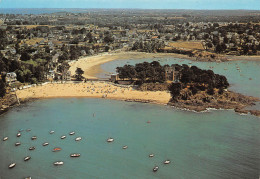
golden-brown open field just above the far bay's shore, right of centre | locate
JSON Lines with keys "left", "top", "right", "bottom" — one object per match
{"left": 168, "top": 41, "right": 204, "bottom": 50}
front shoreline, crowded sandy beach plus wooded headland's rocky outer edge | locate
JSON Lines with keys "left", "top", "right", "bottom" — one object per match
{"left": 13, "top": 81, "right": 260, "bottom": 117}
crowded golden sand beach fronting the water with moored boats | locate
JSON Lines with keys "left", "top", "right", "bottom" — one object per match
{"left": 17, "top": 81, "right": 171, "bottom": 104}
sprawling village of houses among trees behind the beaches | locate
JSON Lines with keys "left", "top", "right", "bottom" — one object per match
{"left": 0, "top": 11, "right": 260, "bottom": 92}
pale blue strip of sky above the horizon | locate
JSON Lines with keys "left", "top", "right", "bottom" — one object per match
{"left": 0, "top": 0, "right": 260, "bottom": 10}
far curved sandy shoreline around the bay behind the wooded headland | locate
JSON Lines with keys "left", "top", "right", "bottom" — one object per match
{"left": 69, "top": 51, "right": 260, "bottom": 79}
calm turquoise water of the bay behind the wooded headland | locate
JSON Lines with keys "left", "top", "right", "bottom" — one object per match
{"left": 98, "top": 58, "right": 260, "bottom": 98}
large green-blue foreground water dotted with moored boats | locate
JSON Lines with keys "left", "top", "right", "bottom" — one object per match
{"left": 0, "top": 98, "right": 260, "bottom": 179}
